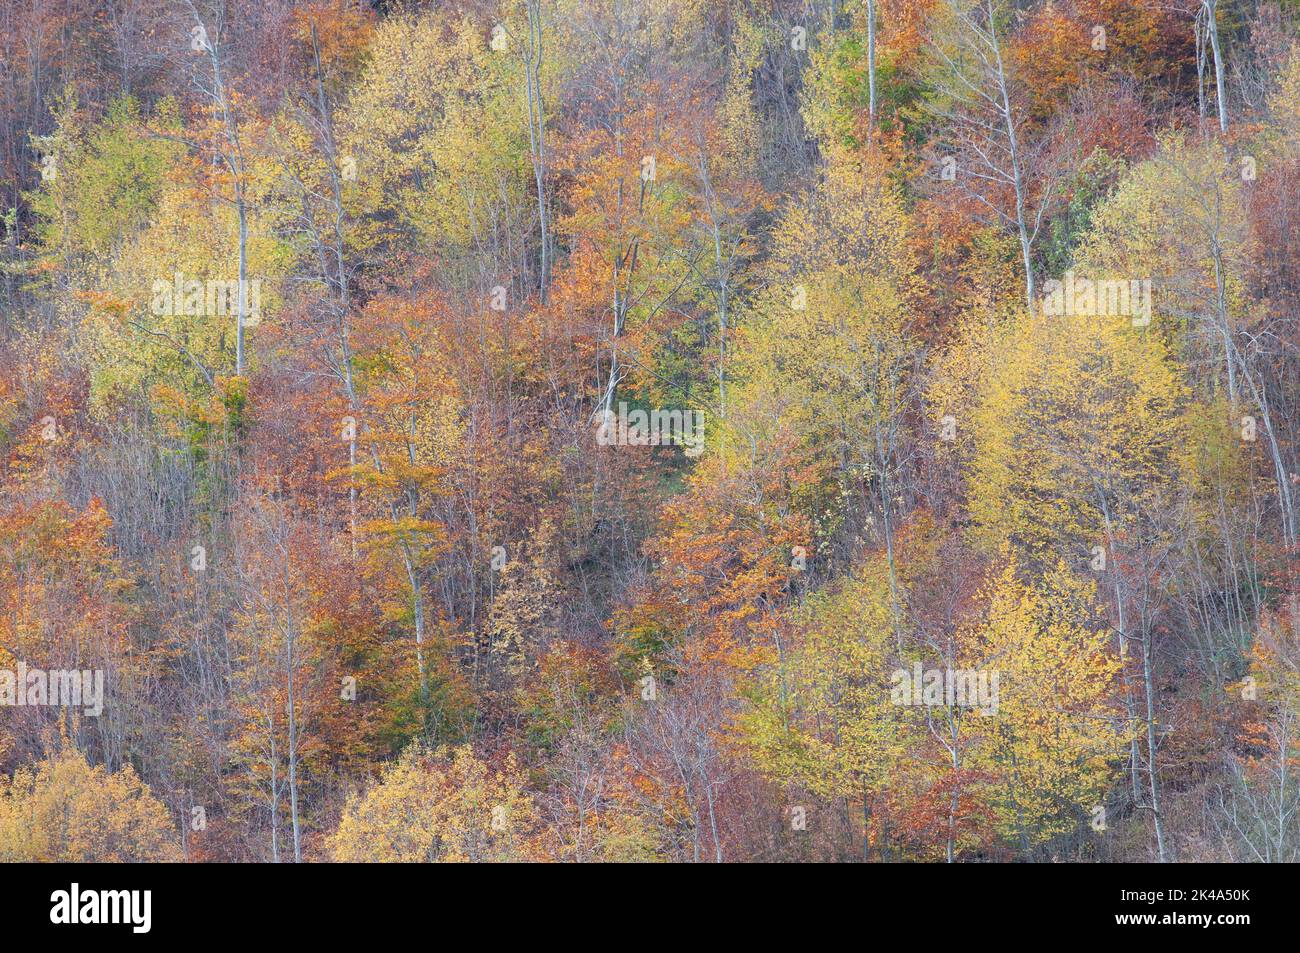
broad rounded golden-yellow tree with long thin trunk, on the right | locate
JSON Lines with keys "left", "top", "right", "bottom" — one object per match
{"left": 932, "top": 301, "right": 1188, "bottom": 853}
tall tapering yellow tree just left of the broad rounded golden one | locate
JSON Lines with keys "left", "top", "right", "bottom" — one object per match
{"left": 736, "top": 148, "right": 919, "bottom": 608}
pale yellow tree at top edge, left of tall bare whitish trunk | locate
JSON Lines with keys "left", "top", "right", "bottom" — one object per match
{"left": 338, "top": 9, "right": 534, "bottom": 294}
